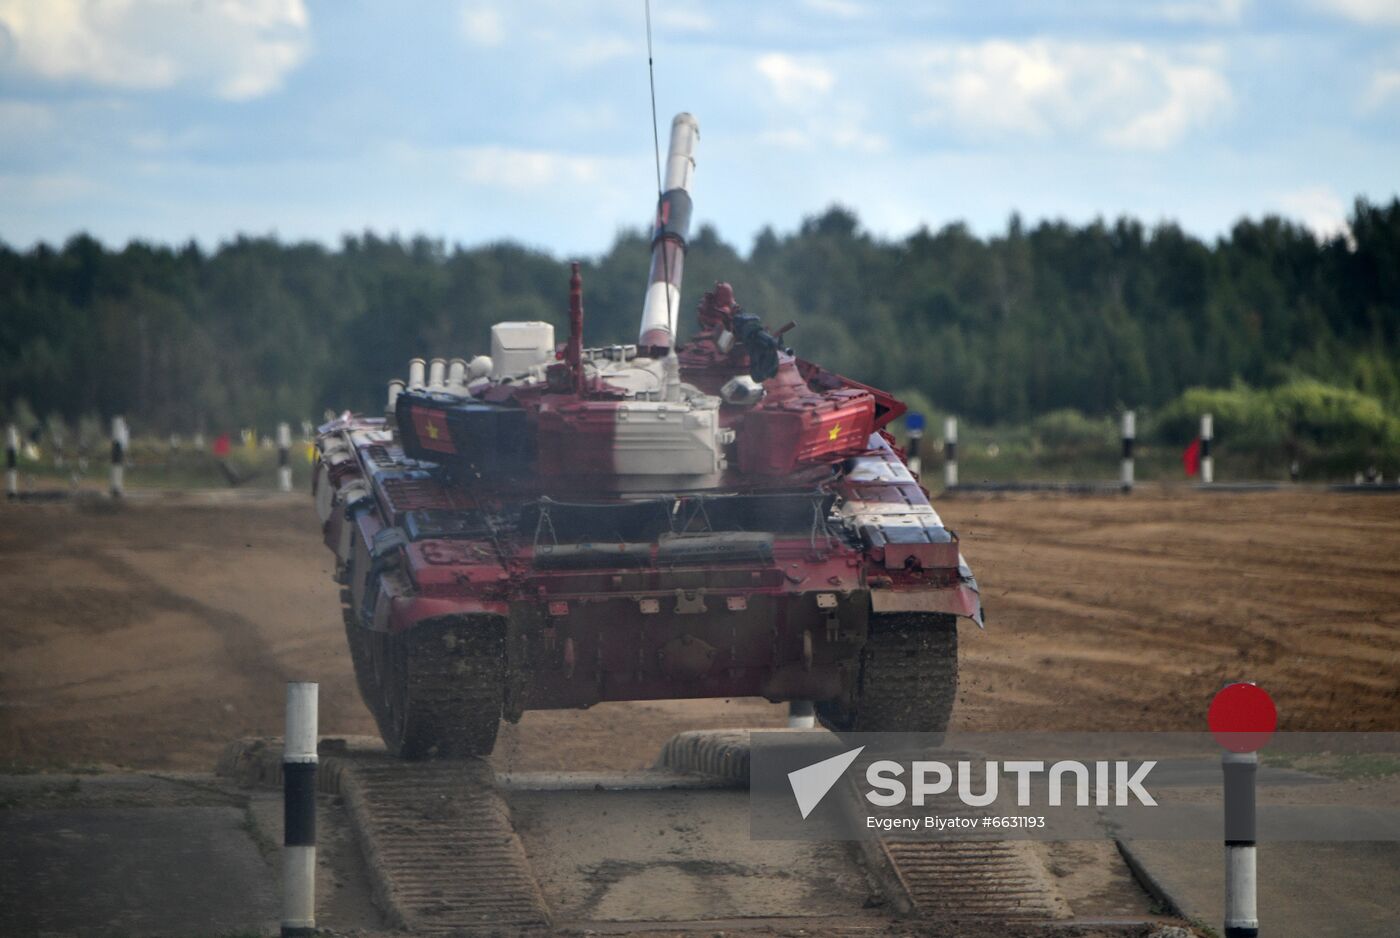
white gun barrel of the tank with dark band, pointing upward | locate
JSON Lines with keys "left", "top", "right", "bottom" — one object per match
{"left": 637, "top": 112, "right": 700, "bottom": 356}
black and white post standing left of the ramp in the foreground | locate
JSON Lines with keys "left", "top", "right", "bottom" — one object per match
{"left": 281, "top": 680, "right": 319, "bottom": 938}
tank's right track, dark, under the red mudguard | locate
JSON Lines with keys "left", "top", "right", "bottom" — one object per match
{"left": 816, "top": 612, "right": 958, "bottom": 732}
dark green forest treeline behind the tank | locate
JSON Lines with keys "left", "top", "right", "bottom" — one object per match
{"left": 0, "top": 200, "right": 1400, "bottom": 445}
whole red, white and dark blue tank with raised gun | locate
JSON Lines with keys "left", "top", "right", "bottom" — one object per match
{"left": 314, "top": 113, "right": 981, "bottom": 759}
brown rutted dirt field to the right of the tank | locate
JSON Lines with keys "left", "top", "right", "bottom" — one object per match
{"left": 939, "top": 491, "right": 1400, "bottom": 729}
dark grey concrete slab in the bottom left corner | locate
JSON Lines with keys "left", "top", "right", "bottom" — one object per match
{"left": 0, "top": 806, "right": 279, "bottom": 938}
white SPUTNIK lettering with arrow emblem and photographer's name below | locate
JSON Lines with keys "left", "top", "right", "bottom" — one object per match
{"left": 788, "top": 746, "right": 1156, "bottom": 829}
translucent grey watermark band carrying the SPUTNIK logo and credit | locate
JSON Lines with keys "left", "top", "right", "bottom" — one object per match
{"left": 749, "top": 731, "right": 1400, "bottom": 841}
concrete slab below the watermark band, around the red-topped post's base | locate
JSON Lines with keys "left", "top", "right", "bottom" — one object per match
{"left": 1126, "top": 840, "right": 1400, "bottom": 938}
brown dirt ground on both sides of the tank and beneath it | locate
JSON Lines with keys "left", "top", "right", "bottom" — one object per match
{"left": 0, "top": 491, "right": 1400, "bottom": 770}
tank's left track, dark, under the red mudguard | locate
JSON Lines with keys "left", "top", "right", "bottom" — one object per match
{"left": 344, "top": 603, "right": 505, "bottom": 760}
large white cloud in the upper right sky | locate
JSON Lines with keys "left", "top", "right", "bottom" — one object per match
{"left": 920, "top": 39, "right": 1231, "bottom": 150}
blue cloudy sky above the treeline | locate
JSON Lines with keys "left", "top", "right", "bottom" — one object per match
{"left": 0, "top": 0, "right": 1400, "bottom": 256}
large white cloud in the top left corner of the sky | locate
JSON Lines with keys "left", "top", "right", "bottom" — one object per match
{"left": 0, "top": 0, "right": 309, "bottom": 101}
